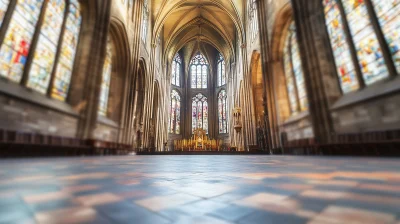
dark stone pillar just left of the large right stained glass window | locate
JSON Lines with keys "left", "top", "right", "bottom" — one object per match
{"left": 292, "top": 0, "right": 334, "bottom": 143}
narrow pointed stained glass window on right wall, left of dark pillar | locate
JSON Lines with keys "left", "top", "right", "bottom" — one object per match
{"left": 283, "top": 22, "right": 308, "bottom": 113}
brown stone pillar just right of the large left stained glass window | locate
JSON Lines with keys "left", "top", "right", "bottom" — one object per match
{"left": 75, "top": 0, "right": 111, "bottom": 139}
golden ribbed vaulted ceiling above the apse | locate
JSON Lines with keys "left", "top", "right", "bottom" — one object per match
{"left": 152, "top": 0, "right": 244, "bottom": 63}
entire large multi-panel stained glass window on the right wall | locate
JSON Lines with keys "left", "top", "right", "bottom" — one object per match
{"left": 323, "top": 0, "right": 400, "bottom": 93}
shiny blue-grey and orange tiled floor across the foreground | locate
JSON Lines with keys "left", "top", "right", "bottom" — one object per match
{"left": 0, "top": 156, "right": 400, "bottom": 224}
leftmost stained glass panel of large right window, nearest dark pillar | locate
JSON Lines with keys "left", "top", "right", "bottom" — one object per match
{"left": 324, "top": 0, "right": 359, "bottom": 93}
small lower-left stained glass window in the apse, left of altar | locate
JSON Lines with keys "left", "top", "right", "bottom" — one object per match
{"left": 169, "top": 90, "right": 181, "bottom": 134}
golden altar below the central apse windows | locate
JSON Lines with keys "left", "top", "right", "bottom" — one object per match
{"left": 174, "top": 128, "right": 222, "bottom": 151}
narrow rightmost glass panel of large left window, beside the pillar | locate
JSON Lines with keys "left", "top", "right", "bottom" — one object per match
{"left": 51, "top": 0, "right": 82, "bottom": 101}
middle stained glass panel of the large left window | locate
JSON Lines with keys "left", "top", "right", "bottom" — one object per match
{"left": 27, "top": 0, "right": 65, "bottom": 94}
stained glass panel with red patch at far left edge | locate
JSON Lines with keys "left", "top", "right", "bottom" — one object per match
{"left": 0, "top": 0, "right": 44, "bottom": 82}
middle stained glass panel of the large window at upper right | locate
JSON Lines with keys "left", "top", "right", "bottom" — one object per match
{"left": 343, "top": 0, "right": 389, "bottom": 85}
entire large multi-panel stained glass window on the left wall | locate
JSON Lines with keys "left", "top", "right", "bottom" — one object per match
{"left": 0, "top": 0, "right": 81, "bottom": 100}
